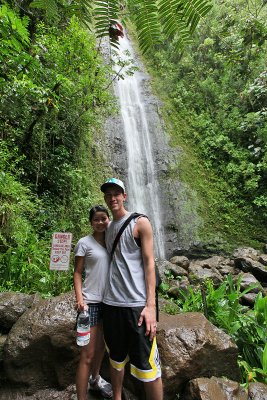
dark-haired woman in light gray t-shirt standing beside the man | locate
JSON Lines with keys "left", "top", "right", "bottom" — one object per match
{"left": 73, "top": 205, "right": 113, "bottom": 400}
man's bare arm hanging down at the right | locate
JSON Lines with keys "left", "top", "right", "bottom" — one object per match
{"left": 136, "top": 217, "right": 157, "bottom": 340}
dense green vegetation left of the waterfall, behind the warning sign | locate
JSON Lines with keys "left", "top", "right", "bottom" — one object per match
{"left": 0, "top": 5, "right": 113, "bottom": 296}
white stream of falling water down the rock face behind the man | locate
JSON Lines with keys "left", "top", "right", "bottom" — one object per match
{"left": 112, "top": 35, "right": 165, "bottom": 258}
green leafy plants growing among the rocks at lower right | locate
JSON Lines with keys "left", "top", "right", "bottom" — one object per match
{"left": 161, "top": 275, "right": 267, "bottom": 384}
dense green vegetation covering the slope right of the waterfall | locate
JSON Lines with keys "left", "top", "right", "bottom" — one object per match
{"left": 143, "top": 0, "right": 267, "bottom": 248}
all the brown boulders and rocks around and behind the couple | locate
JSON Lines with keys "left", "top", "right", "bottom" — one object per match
{"left": 0, "top": 248, "right": 267, "bottom": 400}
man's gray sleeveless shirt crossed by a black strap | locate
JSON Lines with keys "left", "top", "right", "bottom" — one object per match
{"left": 103, "top": 214, "right": 149, "bottom": 307}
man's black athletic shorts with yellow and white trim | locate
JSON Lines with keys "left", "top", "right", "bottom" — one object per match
{"left": 103, "top": 304, "right": 161, "bottom": 382}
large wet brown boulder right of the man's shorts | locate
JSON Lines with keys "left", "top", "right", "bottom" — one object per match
{"left": 157, "top": 313, "right": 240, "bottom": 400}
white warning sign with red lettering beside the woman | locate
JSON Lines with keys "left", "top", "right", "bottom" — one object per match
{"left": 50, "top": 232, "right": 72, "bottom": 271}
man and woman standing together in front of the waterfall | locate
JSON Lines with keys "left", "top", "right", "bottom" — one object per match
{"left": 74, "top": 178, "right": 163, "bottom": 400}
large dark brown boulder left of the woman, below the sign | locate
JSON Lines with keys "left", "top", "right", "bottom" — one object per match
{"left": 3, "top": 292, "right": 79, "bottom": 392}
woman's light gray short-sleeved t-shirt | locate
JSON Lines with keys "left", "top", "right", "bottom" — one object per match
{"left": 74, "top": 235, "right": 110, "bottom": 303}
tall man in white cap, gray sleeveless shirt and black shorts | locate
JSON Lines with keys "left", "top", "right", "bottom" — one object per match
{"left": 101, "top": 178, "right": 163, "bottom": 400}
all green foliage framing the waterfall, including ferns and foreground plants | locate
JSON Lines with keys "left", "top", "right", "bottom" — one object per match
{"left": 0, "top": 0, "right": 267, "bottom": 390}
